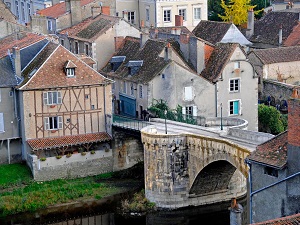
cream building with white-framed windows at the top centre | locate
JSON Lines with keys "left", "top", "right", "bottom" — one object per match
{"left": 116, "top": 0, "right": 207, "bottom": 30}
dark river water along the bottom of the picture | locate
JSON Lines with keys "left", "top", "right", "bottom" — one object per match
{"left": 0, "top": 199, "right": 247, "bottom": 225}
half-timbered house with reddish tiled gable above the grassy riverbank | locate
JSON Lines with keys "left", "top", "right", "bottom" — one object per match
{"left": 18, "top": 42, "right": 113, "bottom": 180}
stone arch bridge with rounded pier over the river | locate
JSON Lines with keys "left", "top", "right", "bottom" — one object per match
{"left": 141, "top": 126, "right": 250, "bottom": 208}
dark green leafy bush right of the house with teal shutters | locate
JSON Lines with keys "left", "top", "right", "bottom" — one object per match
{"left": 258, "top": 104, "right": 287, "bottom": 135}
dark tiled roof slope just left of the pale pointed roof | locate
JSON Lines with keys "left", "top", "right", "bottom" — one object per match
{"left": 192, "top": 20, "right": 232, "bottom": 45}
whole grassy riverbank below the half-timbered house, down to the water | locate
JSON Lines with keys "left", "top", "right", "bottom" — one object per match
{"left": 0, "top": 164, "right": 143, "bottom": 224}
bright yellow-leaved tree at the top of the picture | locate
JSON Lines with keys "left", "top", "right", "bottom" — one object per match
{"left": 219, "top": 0, "right": 261, "bottom": 26}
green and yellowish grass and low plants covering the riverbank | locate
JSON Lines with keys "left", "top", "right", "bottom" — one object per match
{"left": 0, "top": 164, "right": 143, "bottom": 217}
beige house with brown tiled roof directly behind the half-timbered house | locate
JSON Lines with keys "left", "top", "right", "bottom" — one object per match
{"left": 57, "top": 14, "right": 141, "bottom": 70}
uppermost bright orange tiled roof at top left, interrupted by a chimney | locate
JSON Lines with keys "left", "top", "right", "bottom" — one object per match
{"left": 37, "top": 0, "right": 94, "bottom": 18}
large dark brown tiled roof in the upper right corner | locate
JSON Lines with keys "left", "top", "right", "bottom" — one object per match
{"left": 250, "top": 11, "right": 299, "bottom": 46}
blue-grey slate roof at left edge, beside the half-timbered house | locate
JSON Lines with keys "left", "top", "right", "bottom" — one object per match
{"left": 0, "top": 56, "right": 17, "bottom": 87}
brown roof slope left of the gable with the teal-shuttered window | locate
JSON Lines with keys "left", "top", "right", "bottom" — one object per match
{"left": 200, "top": 43, "right": 239, "bottom": 82}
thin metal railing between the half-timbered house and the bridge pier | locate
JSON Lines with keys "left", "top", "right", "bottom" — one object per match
{"left": 113, "top": 114, "right": 151, "bottom": 130}
